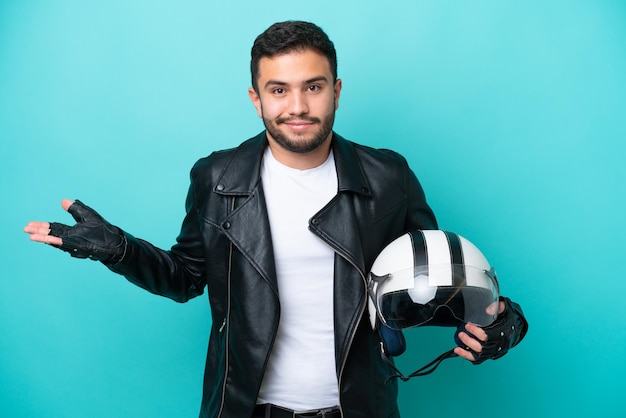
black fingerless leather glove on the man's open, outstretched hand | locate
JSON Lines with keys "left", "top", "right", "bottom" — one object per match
{"left": 50, "top": 200, "right": 126, "bottom": 264}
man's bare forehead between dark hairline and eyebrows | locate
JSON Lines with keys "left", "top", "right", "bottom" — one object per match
{"left": 258, "top": 49, "right": 332, "bottom": 85}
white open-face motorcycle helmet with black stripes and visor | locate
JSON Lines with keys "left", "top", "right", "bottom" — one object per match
{"left": 368, "top": 230, "right": 499, "bottom": 330}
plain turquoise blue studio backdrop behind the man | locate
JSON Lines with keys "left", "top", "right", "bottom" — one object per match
{"left": 0, "top": 0, "right": 626, "bottom": 417}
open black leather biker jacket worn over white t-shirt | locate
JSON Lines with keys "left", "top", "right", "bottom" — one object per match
{"left": 110, "top": 132, "right": 437, "bottom": 418}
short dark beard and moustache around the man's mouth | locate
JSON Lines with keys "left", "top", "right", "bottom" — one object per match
{"left": 263, "top": 110, "right": 335, "bottom": 154}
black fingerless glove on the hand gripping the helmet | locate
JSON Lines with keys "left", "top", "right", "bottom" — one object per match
{"left": 469, "top": 296, "right": 528, "bottom": 364}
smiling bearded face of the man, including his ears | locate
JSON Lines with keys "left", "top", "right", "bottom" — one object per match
{"left": 248, "top": 50, "right": 341, "bottom": 154}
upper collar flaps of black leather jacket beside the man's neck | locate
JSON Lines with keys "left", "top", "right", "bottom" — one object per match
{"left": 215, "top": 131, "right": 370, "bottom": 196}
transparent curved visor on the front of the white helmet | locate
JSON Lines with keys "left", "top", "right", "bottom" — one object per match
{"left": 370, "top": 265, "right": 499, "bottom": 330}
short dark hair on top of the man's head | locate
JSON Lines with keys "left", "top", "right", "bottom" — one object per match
{"left": 250, "top": 20, "right": 337, "bottom": 91}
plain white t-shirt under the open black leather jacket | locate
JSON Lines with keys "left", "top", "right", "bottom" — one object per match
{"left": 257, "top": 147, "right": 339, "bottom": 411}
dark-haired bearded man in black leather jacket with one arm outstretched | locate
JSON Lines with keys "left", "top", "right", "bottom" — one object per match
{"left": 25, "top": 22, "right": 524, "bottom": 418}
